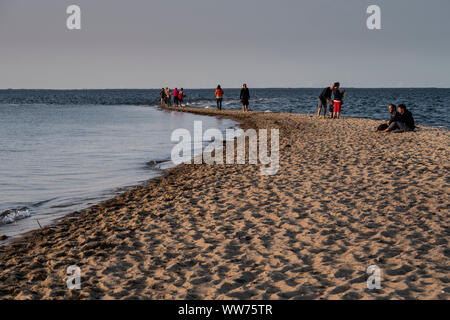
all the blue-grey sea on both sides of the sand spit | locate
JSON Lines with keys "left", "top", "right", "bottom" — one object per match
{"left": 0, "top": 88, "right": 450, "bottom": 241}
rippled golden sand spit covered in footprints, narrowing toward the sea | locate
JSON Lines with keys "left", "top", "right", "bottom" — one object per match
{"left": 0, "top": 108, "right": 450, "bottom": 299}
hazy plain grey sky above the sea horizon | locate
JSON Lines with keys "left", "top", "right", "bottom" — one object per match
{"left": 0, "top": 0, "right": 450, "bottom": 89}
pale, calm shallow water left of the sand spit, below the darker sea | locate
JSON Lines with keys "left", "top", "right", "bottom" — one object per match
{"left": 0, "top": 99, "right": 235, "bottom": 236}
